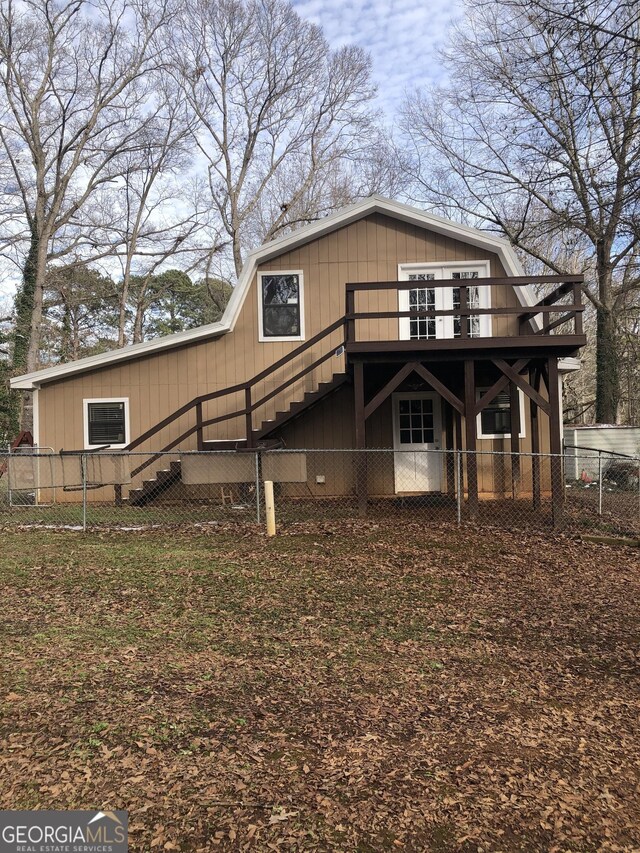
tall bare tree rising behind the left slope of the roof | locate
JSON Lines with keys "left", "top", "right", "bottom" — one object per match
{"left": 172, "top": 0, "right": 374, "bottom": 273}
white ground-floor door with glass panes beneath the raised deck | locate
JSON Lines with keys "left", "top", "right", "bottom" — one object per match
{"left": 393, "top": 391, "right": 442, "bottom": 493}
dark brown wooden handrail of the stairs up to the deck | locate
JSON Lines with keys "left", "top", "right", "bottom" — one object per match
{"left": 124, "top": 317, "right": 346, "bottom": 475}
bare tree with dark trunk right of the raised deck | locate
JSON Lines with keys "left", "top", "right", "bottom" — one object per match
{"left": 403, "top": 0, "right": 640, "bottom": 422}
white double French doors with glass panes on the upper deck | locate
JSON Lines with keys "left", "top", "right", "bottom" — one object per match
{"left": 398, "top": 261, "right": 491, "bottom": 340}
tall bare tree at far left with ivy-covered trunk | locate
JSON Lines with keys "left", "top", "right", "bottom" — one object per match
{"left": 0, "top": 0, "right": 169, "bottom": 425}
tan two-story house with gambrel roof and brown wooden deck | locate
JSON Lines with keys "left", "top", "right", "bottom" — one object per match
{"left": 11, "top": 196, "right": 585, "bottom": 503}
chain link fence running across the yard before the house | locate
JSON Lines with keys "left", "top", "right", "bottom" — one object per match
{"left": 0, "top": 447, "right": 640, "bottom": 537}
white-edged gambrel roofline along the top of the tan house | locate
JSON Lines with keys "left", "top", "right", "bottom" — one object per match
{"left": 11, "top": 195, "right": 536, "bottom": 390}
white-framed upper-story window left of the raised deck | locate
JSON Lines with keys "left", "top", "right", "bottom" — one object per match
{"left": 258, "top": 270, "right": 304, "bottom": 341}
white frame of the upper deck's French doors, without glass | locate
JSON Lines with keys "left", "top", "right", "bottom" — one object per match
{"left": 398, "top": 259, "right": 492, "bottom": 341}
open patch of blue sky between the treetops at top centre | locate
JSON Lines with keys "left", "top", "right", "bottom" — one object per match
{"left": 293, "top": 0, "right": 459, "bottom": 114}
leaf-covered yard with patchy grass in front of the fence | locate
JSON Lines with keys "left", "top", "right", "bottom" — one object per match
{"left": 0, "top": 523, "right": 640, "bottom": 853}
